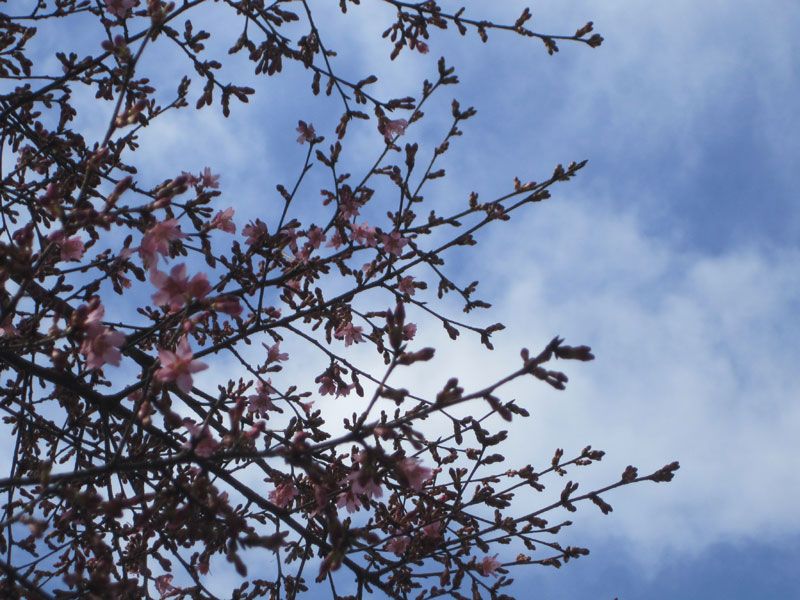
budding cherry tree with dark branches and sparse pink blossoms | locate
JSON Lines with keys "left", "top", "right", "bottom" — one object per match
{"left": 0, "top": 0, "right": 678, "bottom": 598}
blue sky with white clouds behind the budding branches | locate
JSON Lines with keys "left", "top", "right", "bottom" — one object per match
{"left": 7, "top": 0, "right": 800, "bottom": 600}
